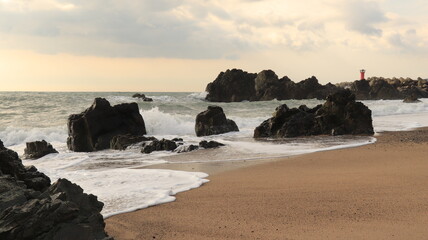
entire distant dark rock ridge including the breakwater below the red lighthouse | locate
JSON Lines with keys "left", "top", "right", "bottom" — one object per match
{"left": 206, "top": 69, "right": 428, "bottom": 102}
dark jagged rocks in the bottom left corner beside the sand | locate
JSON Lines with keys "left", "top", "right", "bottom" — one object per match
{"left": 0, "top": 141, "right": 112, "bottom": 240}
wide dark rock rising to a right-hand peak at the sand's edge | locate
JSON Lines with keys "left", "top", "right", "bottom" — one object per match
{"left": 254, "top": 90, "right": 373, "bottom": 138}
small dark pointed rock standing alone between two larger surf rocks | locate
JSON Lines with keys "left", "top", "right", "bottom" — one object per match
{"left": 195, "top": 106, "right": 239, "bottom": 137}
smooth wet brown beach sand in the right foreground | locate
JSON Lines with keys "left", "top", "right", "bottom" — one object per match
{"left": 106, "top": 128, "right": 428, "bottom": 240}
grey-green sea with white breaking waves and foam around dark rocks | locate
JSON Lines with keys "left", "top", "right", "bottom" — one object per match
{"left": 0, "top": 92, "right": 428, "bottom": 218}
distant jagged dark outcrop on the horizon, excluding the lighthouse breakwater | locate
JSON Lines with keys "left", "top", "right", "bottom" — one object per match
{"left": 206, "top": 69, "right": 340, "bottom": 102}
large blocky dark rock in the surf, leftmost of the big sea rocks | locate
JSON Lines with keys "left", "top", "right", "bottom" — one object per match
{"left": 67, "top": 98, "right": 146, "bottom": 152}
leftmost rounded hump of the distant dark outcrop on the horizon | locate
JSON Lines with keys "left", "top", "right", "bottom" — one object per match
{"left": 206, "top": 69, "right": 256, "bottom": 102}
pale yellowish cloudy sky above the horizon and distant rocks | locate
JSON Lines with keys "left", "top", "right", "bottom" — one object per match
{"left": 0, "top": 0, "right": 428, "bottom": 92}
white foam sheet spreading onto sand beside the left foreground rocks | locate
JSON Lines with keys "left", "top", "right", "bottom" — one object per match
{"left": 24, "top": 156, "right": 208, "bottom": 218}
